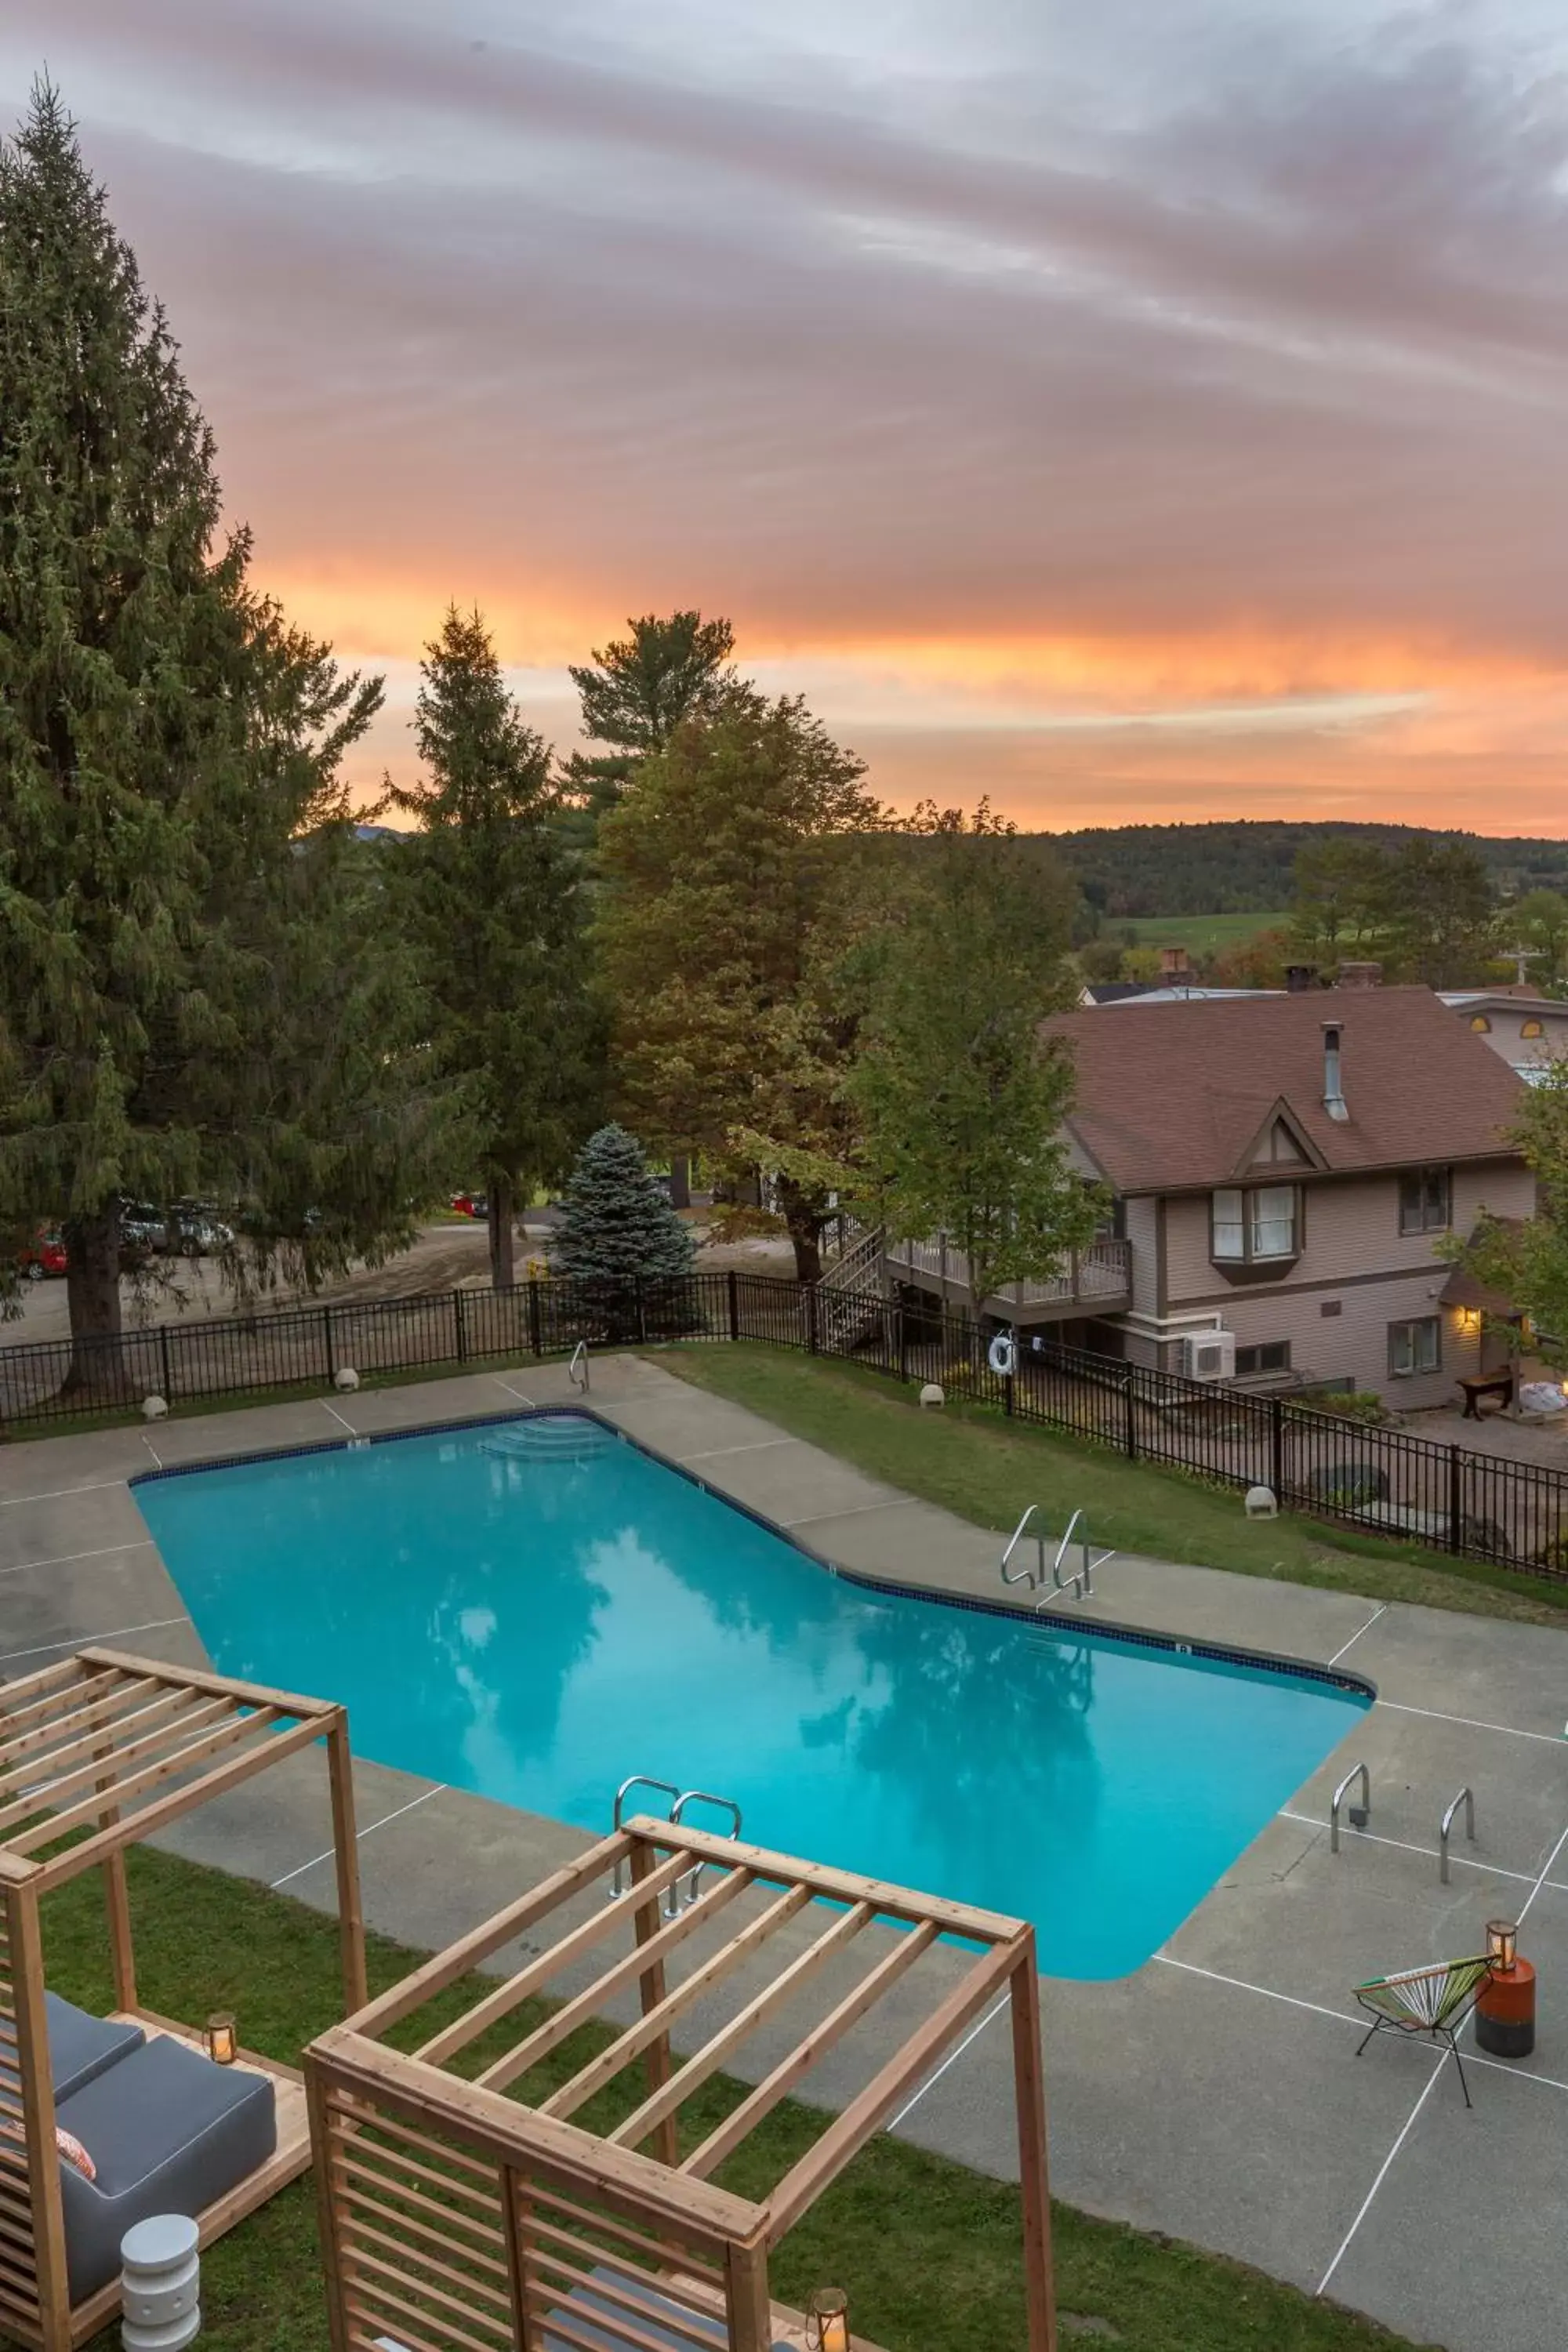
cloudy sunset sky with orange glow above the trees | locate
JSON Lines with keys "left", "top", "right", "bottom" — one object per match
{"left": 0, "top": 0, "right": 1568, "bottom": 833}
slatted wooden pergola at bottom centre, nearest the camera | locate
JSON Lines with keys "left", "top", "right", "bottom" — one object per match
{"left": 306, "top": 1818, "right": 1055, "bottom": 2352}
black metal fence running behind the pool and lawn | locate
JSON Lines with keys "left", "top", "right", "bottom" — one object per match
{"left": 0, "top": 1272, "right": 1568, "bottom": 1581}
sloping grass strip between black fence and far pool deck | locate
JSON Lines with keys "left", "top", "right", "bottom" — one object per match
{"left": 649, "top": 1343, "right": 1568, "bottom": 1625}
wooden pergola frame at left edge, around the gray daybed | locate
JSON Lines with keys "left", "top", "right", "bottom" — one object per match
{"left": 0, "top": 1649, "right": 367, "bottom": 2352}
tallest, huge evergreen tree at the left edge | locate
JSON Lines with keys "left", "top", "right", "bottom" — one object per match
{"left": 0, "top": 82, "right": 440, "bottom": 1381}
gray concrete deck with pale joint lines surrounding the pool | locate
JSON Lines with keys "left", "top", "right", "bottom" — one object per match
{"left": 0, "top": 1357, "right": 1568, "bottom": 2352}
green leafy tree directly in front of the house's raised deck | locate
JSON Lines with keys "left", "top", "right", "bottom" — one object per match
{"left": 848, "top": 804, "right": 1109, "bottom": 1305}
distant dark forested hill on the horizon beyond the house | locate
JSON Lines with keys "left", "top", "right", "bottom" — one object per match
{"left": 1051, "top": 821, "right": 1568, "bottom": 915}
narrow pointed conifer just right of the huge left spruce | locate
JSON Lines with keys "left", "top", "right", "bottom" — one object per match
{"left": 393, "top": 604, "right": 600, "bottom": 1287}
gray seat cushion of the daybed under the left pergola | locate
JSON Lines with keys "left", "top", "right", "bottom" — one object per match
{"left": 56, "top": 2034, "right": 278, "bottom": 2303}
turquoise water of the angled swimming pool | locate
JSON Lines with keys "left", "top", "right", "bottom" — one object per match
{"left": 136, "top": 1418, "right": 1366, "bottom": 1978}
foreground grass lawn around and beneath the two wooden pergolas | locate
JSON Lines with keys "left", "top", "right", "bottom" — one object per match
{"left": 45, "top": 1846, "right": 1429, "bottom": 2352}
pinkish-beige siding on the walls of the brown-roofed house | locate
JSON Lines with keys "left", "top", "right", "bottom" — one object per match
{"left": 1147, "top": 1162, "right": 1533, "bottom": 1409}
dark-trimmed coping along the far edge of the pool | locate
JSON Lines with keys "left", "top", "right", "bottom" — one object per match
{"left": 127, "top": 1404, "right": 1377, "bottom": 1705}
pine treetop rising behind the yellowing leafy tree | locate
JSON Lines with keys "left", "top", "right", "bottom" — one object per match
{"left": 567, "top": 612, "right": 736, "bottom": 826}
